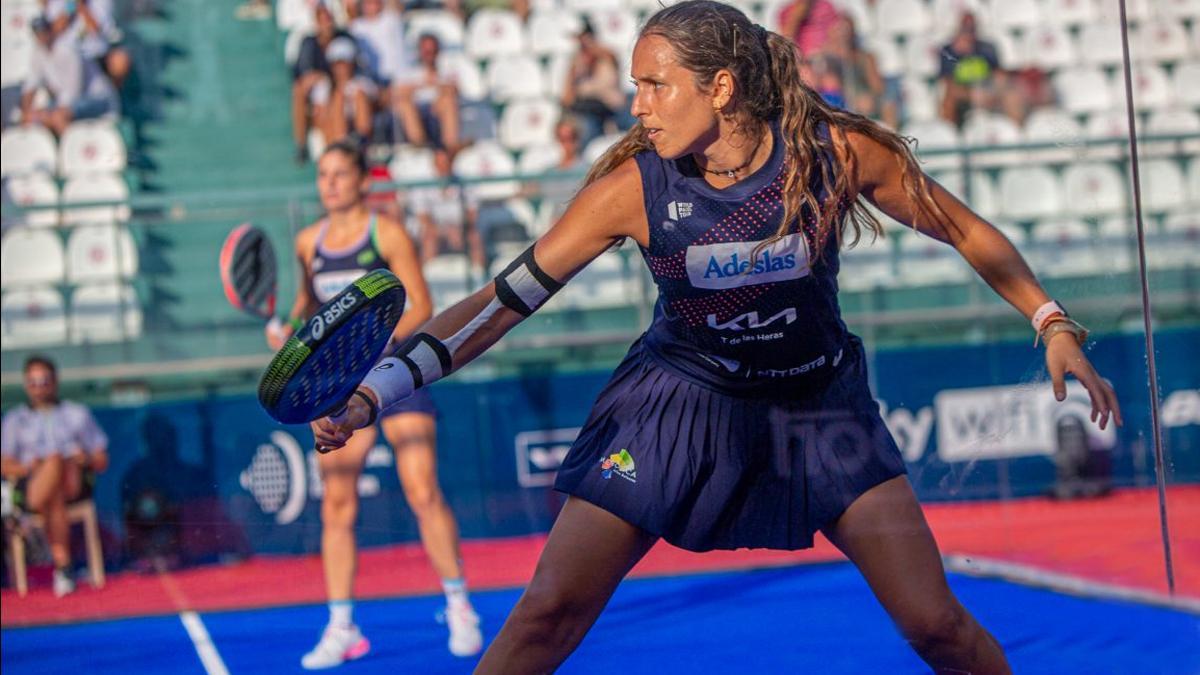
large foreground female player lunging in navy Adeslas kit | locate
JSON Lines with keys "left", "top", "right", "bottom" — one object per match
{"left": 314, "top": 0, "right": 1121, "bottom": 674}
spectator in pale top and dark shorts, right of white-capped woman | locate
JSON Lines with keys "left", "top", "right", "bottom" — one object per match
{"left": 392, "top": 34, "right": 462, "bottom": 153}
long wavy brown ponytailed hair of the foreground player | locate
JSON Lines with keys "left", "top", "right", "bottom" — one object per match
{"left": 583, "top": 0, "right": 946, "bottom": 256}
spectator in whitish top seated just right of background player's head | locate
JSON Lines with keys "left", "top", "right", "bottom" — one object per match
{"left": 408, "top": 149, "right": 487, "bottom": 269}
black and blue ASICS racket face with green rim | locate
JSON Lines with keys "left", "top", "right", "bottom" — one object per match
{"left": 258, "top": 270, "right": 404, "bottom": 424}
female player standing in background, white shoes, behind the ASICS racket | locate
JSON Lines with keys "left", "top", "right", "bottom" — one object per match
{"left": 266, "top": 143, "right": 482, "bottom": 668}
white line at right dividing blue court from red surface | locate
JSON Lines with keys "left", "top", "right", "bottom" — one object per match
{"left": 944, "top": 555, "right": 1200, "bottom": 614}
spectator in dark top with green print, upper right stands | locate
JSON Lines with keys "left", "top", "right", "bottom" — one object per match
{"left": 938, "top": 12, "right": 1026, "bottom": 125}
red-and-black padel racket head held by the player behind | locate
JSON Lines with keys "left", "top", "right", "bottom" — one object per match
{"left": 221, "top": 222, "right": 276, "bottom": 318}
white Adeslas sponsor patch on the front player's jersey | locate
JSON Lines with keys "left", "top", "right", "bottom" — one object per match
{"left": 688, "top": 234, "right": 810, "bottom": 288}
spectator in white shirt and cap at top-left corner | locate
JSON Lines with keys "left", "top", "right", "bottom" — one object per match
{"left": 20, "top": 0, "right": 120, "bottom": 135}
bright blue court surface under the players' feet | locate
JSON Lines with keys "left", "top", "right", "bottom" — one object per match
{"left": 2, "top": 565, "right": 1200, "bottom": 675}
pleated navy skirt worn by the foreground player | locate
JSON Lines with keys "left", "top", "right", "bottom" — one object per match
{"left": 554, "top": 339, "right": 905, "bottom": 551}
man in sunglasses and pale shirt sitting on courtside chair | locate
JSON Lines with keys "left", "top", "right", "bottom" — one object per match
{"left": 0, "top": 357, "right": 108, "bottom": 597}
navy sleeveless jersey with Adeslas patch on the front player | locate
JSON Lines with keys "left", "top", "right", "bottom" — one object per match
{"left": 635, "top": 124, "right": 848, "bottom": 395}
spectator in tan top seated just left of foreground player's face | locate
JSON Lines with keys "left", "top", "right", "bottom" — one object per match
{"left": 562, "top": 19, "right": 631, "bottom": 145}
